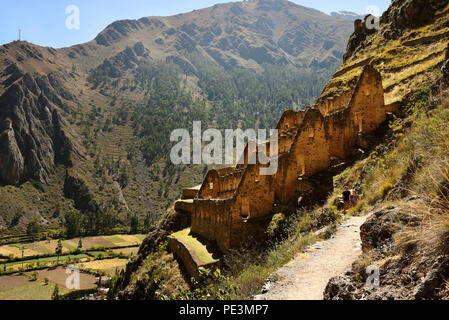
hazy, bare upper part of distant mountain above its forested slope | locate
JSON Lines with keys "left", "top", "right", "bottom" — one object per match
{"left": 89, "top": 0, "right": 353, "bottom": 69}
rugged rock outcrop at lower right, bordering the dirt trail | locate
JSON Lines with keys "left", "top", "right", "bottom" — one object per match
{"left": 324, "top": 205, "right": 449, "bottom": 300}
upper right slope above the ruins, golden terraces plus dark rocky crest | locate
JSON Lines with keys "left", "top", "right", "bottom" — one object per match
{"left": 320, "top": 1, "right": 449, "bottom": 104}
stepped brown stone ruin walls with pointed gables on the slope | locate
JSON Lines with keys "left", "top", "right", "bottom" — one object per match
{"left": 178, "top": 65, "right": 389, "bottom": 252}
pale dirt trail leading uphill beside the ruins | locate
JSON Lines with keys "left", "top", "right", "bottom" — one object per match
{"left": 255, "top": 216, "right": 367, "bottom": 300}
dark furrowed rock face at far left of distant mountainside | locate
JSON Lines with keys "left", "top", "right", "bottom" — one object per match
{"left": 0, "top": 65, "right": 81, "bottom": 185}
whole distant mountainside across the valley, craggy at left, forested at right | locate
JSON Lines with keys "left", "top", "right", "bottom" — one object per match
{"left": 0, "top": 0, "right": 352, "bottom": 237}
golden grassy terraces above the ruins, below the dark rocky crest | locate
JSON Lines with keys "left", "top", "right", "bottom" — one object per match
{"left": 319, "top": 13, "right": 449, "bottom": 104}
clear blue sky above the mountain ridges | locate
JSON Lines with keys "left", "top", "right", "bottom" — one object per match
{"left": 0, "top": 0, "right": 391, "bottom": 48}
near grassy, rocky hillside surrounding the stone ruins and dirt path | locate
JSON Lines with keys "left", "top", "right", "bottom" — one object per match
{"left": 114, "top": 0, "right": 449, "bottom": 299}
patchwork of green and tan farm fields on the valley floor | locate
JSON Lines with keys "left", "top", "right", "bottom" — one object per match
{"left": 0, "top": 234, "right": 145, "bottom": 300}
